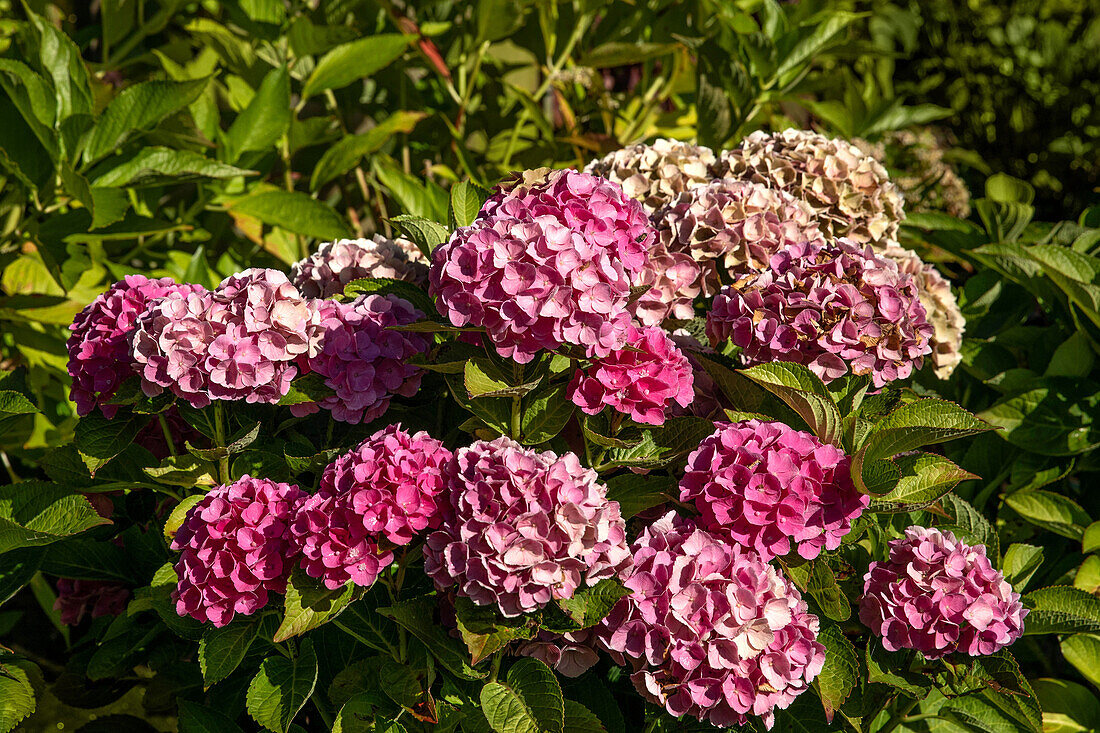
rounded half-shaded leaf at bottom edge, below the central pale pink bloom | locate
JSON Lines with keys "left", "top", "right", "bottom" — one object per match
{"left": 481, "top": 657, "right": 565, "bottom": 733}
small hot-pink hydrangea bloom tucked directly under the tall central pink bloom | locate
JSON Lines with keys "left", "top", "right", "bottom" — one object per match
{"left": 569, "top": 326, "right": 695, "bottom": 425}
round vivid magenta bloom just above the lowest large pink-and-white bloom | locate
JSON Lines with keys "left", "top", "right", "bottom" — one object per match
{"left": 680, "top": 420, "right": 870, "bottom": 560}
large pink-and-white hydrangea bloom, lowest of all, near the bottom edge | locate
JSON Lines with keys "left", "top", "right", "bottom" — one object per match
{"left": 597, "top": 512, "right": 825, "bottom": 727}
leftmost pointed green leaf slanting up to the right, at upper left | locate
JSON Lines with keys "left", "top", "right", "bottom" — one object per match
{"left": 84, "top": 77, "right": 209, "bottom": 164}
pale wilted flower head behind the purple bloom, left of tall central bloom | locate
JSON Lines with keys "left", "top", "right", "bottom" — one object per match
{"left": 290, "top": 234, "right": 428, "bottom": 298}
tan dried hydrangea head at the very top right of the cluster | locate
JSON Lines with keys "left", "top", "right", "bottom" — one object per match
{"left": 718, "top": 130, "right": 905, "bottom": 244}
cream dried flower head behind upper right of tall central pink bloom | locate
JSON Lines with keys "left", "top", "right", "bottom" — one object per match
{"left": 584, "top": 138, "right": 718, "bottom": 214}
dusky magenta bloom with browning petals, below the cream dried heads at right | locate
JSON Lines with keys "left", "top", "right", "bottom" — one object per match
{"left": 706, "top": 240, "right": 934, "bottom": 387}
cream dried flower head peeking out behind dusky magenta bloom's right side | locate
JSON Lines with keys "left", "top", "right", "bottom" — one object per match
{"left": 881, "top": 240, "right": 966, "bottom": 380}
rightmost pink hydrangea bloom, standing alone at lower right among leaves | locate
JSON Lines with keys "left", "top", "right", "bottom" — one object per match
{"left": 859, "top": 527, "right": 1027, "bottom": 659}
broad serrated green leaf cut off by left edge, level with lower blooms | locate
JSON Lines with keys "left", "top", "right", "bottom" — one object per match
{"left": 0, "top": 481, "right": 110, "bottom": 553}
